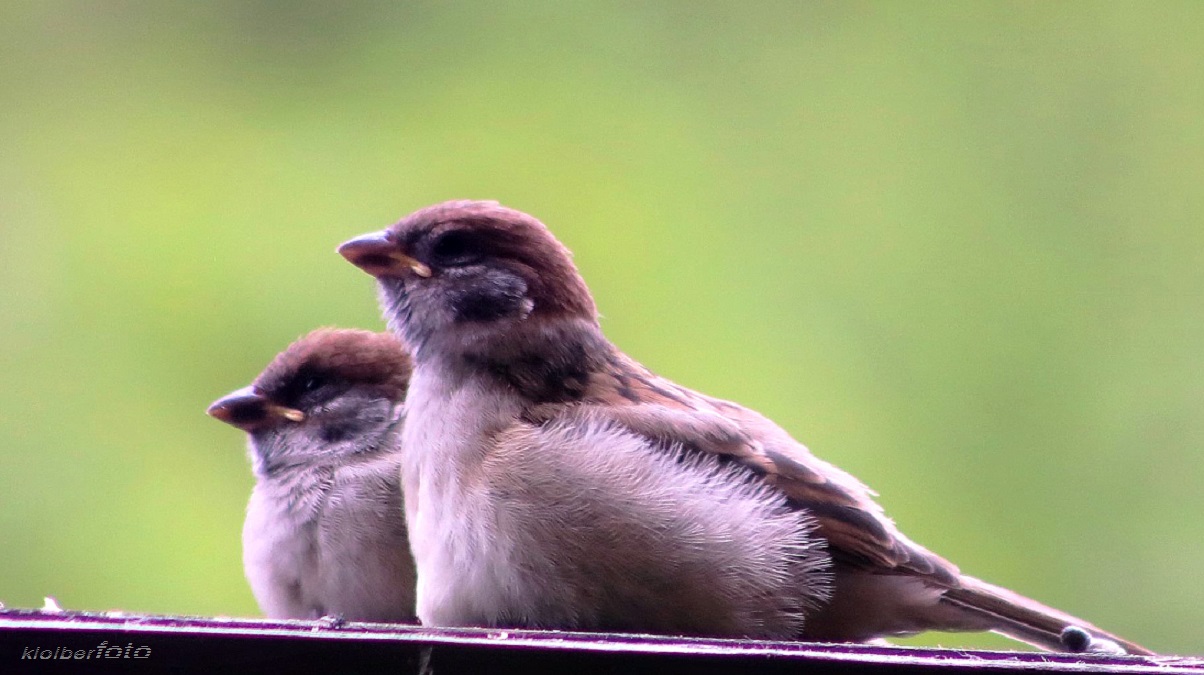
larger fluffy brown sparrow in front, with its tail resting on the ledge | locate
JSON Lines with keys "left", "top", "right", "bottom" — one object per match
{"left": 338, "top": 201, "right": 1150, "bottom": 653}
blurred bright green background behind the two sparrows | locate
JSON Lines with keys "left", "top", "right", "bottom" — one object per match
{"left": 0, "top": 1, "right": 1204, "bottom": 653}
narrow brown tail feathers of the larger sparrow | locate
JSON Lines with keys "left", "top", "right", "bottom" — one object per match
{"left": 942, "top": 576, "right": 1153, "bottom": 655}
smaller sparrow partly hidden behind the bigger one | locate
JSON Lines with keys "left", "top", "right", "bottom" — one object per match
{"left": 208, "top": 328, "right": 415, "bottom": 622}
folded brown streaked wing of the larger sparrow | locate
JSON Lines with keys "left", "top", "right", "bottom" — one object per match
{"left": 530, "top": 353, "right": 958, "bottom": 587}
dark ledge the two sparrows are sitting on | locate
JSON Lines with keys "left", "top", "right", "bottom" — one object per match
{"left": 0, "top": 609, "right": 1204, "bottom": 675}
